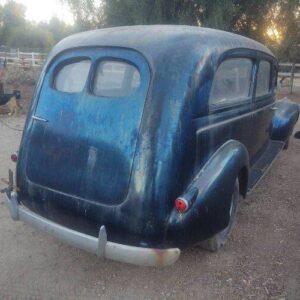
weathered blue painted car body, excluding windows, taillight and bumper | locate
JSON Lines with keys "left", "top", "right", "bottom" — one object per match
{"left": 17, "top": 26, "right": 300, "bottom": 248}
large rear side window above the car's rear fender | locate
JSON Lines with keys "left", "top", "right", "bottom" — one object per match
{"left": 209, "top": 58, "right": 253, "bottom": 109}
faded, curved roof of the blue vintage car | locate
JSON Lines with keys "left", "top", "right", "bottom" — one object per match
{"left": 49, "top": 25, "right": 274, "bottom": 61}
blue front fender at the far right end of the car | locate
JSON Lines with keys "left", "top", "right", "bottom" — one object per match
{"left": 271, "top": 101, "right": 299, "bottom": 142}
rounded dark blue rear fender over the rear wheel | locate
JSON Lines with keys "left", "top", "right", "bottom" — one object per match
{"left": 167, "top": 140, "right": 249, "bottom": 247}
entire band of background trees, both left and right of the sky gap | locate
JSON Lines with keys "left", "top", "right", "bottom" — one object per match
{"left": 0, "top": 0, "right": 300, "bottom": 61}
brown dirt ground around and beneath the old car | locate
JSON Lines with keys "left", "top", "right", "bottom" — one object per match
{"left": 0, "top": 88, "right": 300, "bottom": 300}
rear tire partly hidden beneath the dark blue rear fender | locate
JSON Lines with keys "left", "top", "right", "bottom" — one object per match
{"left": 199, "top": 179, "right": 240, "bottom": 252}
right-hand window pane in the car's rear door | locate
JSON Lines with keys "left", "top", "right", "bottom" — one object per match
{"left": 93, "top": 60, "right": 141, "bottom": 97}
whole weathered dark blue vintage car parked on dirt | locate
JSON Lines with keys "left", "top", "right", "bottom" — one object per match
{"left": 3, "top": 26, "right": 299, "bottom": 266}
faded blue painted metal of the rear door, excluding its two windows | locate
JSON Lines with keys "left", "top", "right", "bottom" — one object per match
{"left": 26, "top": 49, "right": 150, "bottom": 205}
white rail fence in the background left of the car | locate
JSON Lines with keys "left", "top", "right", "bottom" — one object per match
{"left": 0, "top": 51, "right": 47, "bottom": 68}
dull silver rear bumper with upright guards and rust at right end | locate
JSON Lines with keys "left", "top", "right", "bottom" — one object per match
{"left": 5, "top": 193, "right": 180, "bottom": 266}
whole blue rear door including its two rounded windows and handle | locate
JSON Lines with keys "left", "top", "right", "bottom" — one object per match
{"left": 24, "top": 49, "right": 150, "bottom": 205}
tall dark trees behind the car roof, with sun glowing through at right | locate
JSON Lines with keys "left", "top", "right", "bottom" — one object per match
{"left": 63, "top": 0, "right": 300, "bottom": 61}
